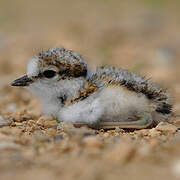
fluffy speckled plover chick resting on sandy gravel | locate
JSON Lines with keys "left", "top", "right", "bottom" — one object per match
{"left": 11, "top": 48, "right": 172, "bottom": 129}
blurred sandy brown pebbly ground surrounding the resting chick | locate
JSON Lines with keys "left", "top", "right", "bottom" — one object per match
{"left": 0, "top": 0, "right": 180, "bottom": 180}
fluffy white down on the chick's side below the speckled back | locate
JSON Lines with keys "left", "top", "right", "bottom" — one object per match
{"left": 58, "top": 86, "right": 151, "bottom": 123}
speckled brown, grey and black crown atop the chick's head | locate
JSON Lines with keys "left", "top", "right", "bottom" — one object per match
{"left": 36, "top": 48, "right": 87, "bottom": 79}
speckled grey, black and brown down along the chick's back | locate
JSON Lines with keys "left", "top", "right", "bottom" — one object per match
{"left": 88, "top": 66, "right": 172, "bottom": 114}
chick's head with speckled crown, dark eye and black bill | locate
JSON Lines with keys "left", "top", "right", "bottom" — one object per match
{"left": 11, "top": 48, "right": 87, "bottom": 99}
